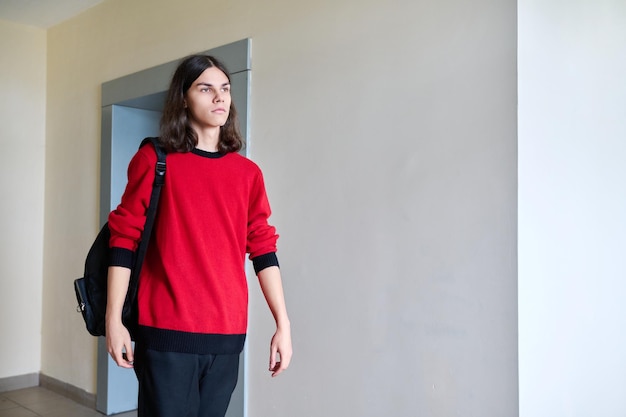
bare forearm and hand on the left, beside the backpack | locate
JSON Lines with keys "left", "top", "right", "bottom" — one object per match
{"left": 106, "top": 266, "right": 134, "bottom": 368}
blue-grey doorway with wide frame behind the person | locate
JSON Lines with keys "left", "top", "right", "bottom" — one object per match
{"left": 96, "top": 39, "right": 251, "bottom": 417}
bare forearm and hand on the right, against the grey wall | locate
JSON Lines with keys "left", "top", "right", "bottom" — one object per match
{"left": 258, "top": 266, "right": 293, "bottom": 377}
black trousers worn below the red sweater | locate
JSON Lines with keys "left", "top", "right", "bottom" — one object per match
{"left": 134, "top": 346, "right": 239, "bottom": 417}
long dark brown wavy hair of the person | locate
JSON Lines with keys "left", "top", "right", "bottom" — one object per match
{"left": 160, "top": 55, "right": 243, "bottom": 153}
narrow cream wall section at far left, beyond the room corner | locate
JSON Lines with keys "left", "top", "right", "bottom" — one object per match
{"left": 0, "top": 20, "right": 46, "bottom": 378}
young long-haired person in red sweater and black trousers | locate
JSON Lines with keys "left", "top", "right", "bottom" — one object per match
{"left": 106, "top": 55, "right": 292, "bottom": 417}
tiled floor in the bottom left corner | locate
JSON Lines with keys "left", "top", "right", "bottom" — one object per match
{"left": 0, "top": 387, "right": 137, "bottom": 417}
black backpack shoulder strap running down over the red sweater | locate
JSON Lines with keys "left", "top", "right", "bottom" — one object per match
{"left": 126, "top": 138, "right": 166, "bottom": 324}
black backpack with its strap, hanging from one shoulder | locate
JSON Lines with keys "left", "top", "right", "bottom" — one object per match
{"left": 74, "top": 138, "right": 166, "bottom": 340}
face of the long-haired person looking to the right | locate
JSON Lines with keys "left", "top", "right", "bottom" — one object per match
{"left": 185, "top": 67, "right": 231, "bottom": 130}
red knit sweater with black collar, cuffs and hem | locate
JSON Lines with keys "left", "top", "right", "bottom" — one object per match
{"left": 109, "top": 145, "right": 278, "bottom": 354}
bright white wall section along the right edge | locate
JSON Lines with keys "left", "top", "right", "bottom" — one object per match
{"left": 519, "top": 0, "right": 626, "bottom": 417}
